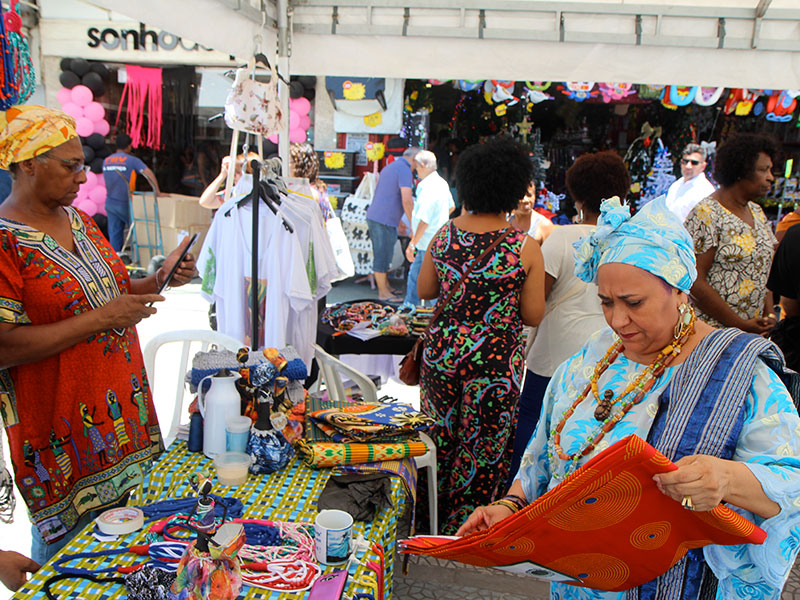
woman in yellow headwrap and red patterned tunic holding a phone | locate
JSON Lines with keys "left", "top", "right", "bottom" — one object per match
{"left": 0, "top": 106, "right": 195, "bottom": 563}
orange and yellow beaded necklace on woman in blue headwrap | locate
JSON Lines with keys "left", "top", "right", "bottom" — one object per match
{"left": 547, "top": 307, "right": 696, "bottom": 479}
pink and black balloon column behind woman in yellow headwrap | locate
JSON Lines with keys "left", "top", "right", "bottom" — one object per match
{"left": 57, "top": 58, "right": 111, "bottom": 217}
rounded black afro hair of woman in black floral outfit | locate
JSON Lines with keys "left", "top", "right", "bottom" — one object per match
{"left": 456, "top": 140, "right": 533, "bottom": 213}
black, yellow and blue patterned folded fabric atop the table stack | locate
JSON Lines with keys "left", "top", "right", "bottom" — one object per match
{"left": 310, "top": 403, "right": 434, "bottom": 442}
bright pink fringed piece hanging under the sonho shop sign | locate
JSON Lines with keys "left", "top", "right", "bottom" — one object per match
{"left": 114, "top": 65, "right": 163, "bottom": 150}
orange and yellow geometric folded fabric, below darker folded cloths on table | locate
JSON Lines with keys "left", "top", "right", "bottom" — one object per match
{"left": 297, "top": 441, "right": 428, "bottom": 469}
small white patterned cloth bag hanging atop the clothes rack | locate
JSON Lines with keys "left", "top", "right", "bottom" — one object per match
{"left": 225, "top": 59, "right": 283, "bottom": 137}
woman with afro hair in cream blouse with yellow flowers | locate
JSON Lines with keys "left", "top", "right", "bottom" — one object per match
{"left": 684, "top": 134, "right": 778, "bottom": 334}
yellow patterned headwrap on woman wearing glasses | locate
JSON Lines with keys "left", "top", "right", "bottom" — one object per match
{"left": 0, "top": 104, "right": 78, "bottom": 170}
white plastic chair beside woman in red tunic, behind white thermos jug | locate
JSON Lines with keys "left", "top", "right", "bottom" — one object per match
{"left": 143, "top": 329, "right": 244, "bottom": 447}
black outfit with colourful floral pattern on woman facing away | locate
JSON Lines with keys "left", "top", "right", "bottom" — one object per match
{"left": 420, "top": 221, "right": 526, "bottom": 534}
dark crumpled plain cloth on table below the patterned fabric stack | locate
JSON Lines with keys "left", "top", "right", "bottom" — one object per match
{"left": 317, "top": 473, "right": 392, "bottom": 521}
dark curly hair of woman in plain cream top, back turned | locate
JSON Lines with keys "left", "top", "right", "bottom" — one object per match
{"left": 567, "top": 150, "right": 631, "bottom": 214}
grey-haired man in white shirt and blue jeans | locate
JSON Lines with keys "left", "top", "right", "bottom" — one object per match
{"left": 404, "top": 150, "right": 455, "bottom": 306}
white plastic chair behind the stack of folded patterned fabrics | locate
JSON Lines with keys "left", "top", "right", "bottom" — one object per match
{"left": 313, "top": 344, "right": 439, "bottom": 535}
